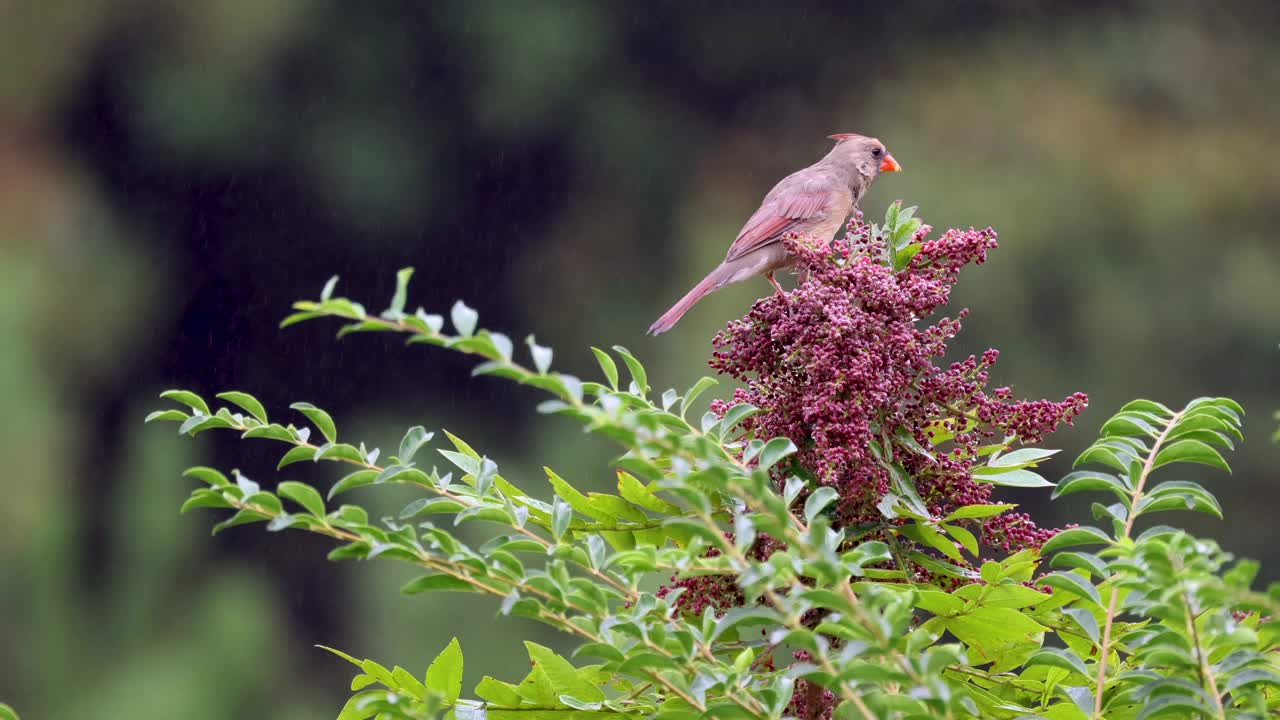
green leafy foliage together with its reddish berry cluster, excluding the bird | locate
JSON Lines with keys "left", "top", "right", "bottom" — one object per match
{"left": 147, "top": 204, "right": 1280, "bottom": 720}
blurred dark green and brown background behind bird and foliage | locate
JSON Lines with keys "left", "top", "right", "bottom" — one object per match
{"left": 0, "top": 0, "right": 1280, "bottom": 719}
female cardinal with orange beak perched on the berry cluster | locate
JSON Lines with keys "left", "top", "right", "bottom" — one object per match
{"left": 649, "top": 133, "right": 902, "bottom": 334}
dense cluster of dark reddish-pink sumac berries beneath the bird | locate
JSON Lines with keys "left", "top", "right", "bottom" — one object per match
{"left": 710, "top": 213, "right": 1088, "bottom": 550}
